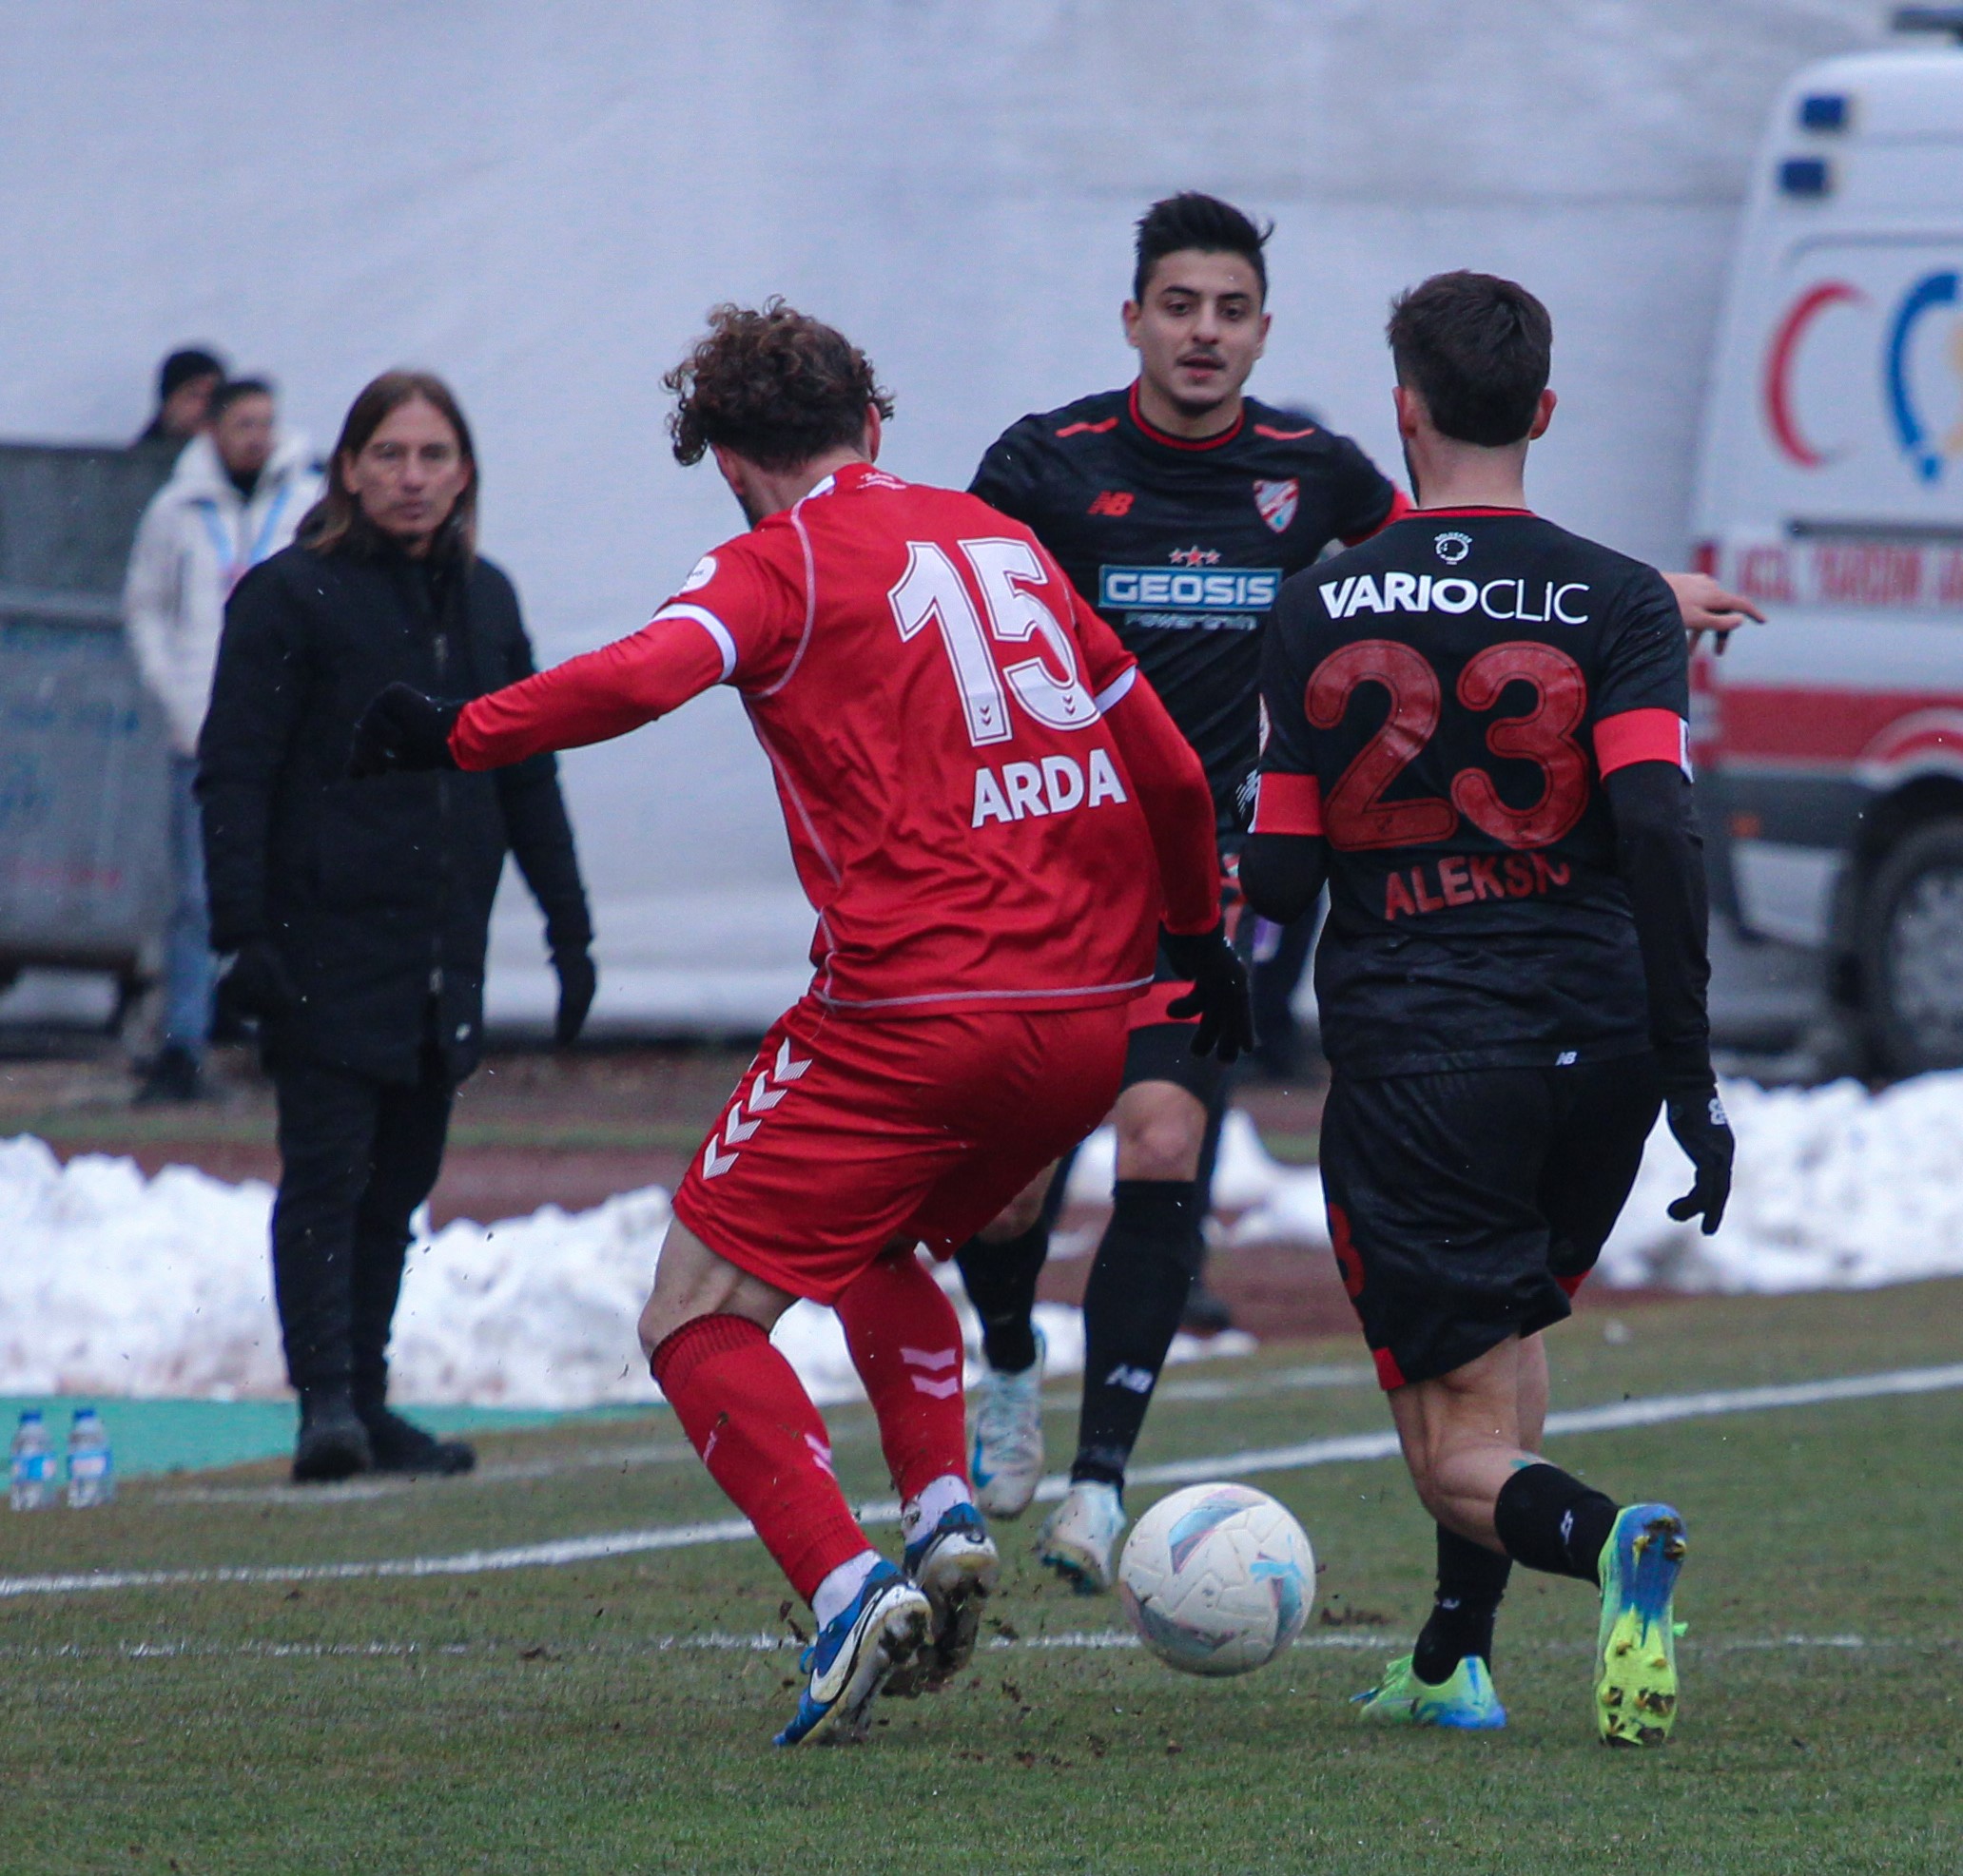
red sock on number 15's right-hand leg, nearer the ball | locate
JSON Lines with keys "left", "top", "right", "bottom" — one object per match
{"left": 832, "top": 1247, "right": 968, "bottom": 1503}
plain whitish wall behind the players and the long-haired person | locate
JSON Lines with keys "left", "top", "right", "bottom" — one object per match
{"left": 0, "top": 0, "right": 1887, "bottom": 1026}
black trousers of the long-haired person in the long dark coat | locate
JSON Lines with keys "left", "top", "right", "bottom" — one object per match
{"left": 267, "top": 1044, "right": 456, "bottom": 1403}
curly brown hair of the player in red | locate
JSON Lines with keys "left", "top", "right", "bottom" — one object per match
{"left": 662, "top": 297, "right": 893, "bottom": 471}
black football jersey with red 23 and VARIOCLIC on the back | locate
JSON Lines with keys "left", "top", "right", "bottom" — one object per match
{"left": 1254, "top": 509, "right": 1690, "bottom": 1075}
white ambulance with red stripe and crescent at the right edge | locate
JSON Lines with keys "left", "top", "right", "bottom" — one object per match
{"left": 1694, "top": 8, "right": 1963, "bottom": 1073}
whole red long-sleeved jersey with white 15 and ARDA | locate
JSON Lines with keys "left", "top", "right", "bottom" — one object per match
{"left": 452, "top": 463, "right": 1219, "bottom": 1016}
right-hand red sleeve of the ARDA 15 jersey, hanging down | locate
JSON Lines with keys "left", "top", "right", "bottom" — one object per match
{"left": 1068, "top": 587, "right": 1221, "bottom": 934}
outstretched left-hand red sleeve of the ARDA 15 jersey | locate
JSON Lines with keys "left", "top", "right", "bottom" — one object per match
{"left": 450, "top": 533, "right": 807, "bottom": 769}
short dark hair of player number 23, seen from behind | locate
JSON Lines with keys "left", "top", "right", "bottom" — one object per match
{"left": 1388, "top": 273, "right": 1555, "bottom": 450}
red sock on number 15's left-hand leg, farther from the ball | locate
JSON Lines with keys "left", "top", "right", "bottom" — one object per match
{"left": 651, "top": 1315, "right": 871, "bottom": 1603}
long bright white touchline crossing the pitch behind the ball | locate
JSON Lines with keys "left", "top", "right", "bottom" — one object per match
{"left": 0, "top": 1362, "right": 1963, "bottom": 1597}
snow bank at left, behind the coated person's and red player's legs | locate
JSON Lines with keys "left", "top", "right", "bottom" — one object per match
{"left": 0, "top": 1138, "right": 1253, "bottom": 1407}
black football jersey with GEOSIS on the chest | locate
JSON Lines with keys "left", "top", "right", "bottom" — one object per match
{"left": 972, "top": 385, "right": 1396, "bottom": 834}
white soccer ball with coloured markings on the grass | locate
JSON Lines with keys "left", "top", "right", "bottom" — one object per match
{"left": 1117, "top": 1485, "right": 1315, "bottom": 1673}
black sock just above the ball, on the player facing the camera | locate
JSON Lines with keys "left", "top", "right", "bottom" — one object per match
{"left": 1070, "top": 1179, "right": 1201, "bottom": 1485}
